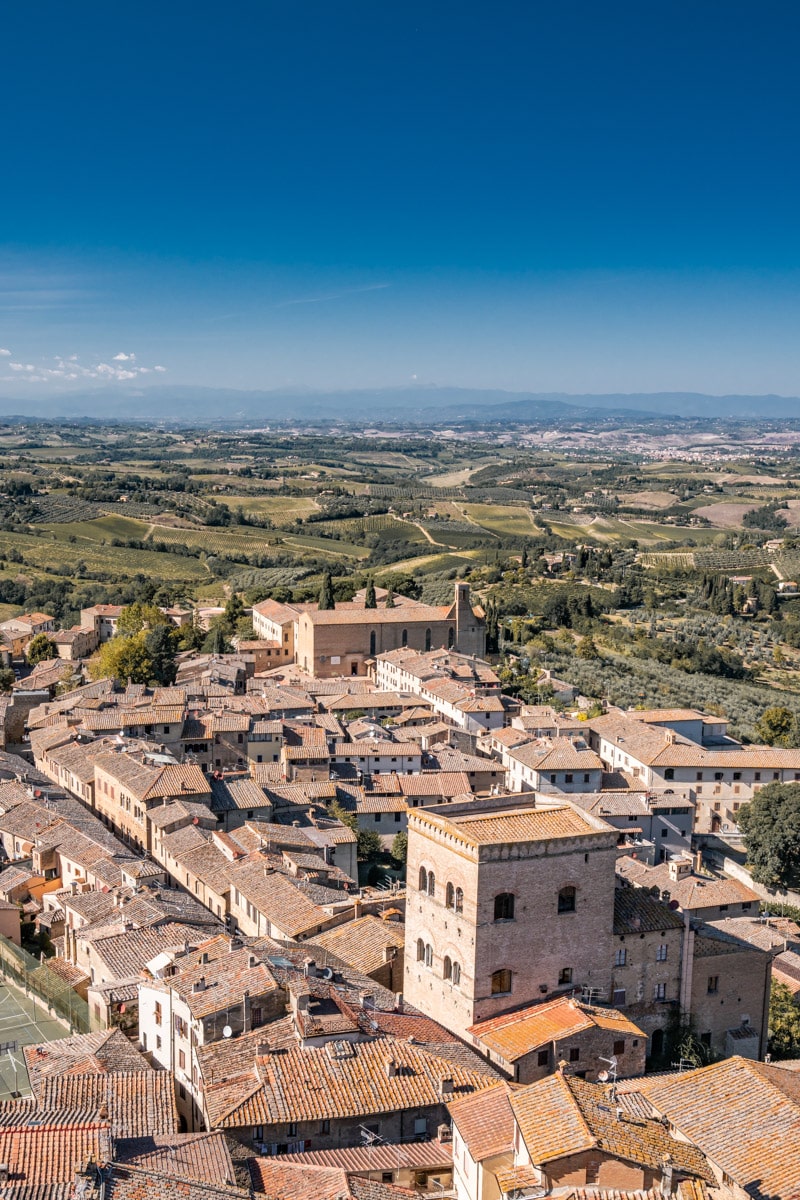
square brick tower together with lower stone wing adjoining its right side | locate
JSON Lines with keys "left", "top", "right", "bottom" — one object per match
{"left": 404, "top": 792, "right": 772, "bottom": 1068}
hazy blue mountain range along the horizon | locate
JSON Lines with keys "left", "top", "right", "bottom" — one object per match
{"left": 0, "top": 384, "right": 800, "bottom": 428}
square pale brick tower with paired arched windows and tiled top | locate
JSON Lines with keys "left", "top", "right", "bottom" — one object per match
{"left": 405, "top": 796, "right": 618, "bottom": 1036}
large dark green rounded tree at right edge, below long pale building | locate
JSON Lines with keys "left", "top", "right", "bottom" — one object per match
{"left": 739, "top": 784, "right": 800, "bottom": 888}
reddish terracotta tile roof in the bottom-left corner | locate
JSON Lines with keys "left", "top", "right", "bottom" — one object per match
{"left": 0, "top": 1120, "right": 112, "bottom": 1196}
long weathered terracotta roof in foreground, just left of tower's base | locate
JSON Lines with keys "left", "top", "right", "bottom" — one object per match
{"left": 205, "top": 1039, "right": 491, "bottom": 1129}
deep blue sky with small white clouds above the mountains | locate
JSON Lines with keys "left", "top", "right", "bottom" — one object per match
{"left": 0, "top": 0, "right": 800, "bottom": 396}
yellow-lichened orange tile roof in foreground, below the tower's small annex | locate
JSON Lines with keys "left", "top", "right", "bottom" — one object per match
{"left": 511, "top": 1073, "right": 714, "bottom": 1181}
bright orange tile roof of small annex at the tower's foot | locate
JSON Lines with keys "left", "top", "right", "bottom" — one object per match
{"left": 467, "top": 996, "right": 645, "bottom": 1062}
